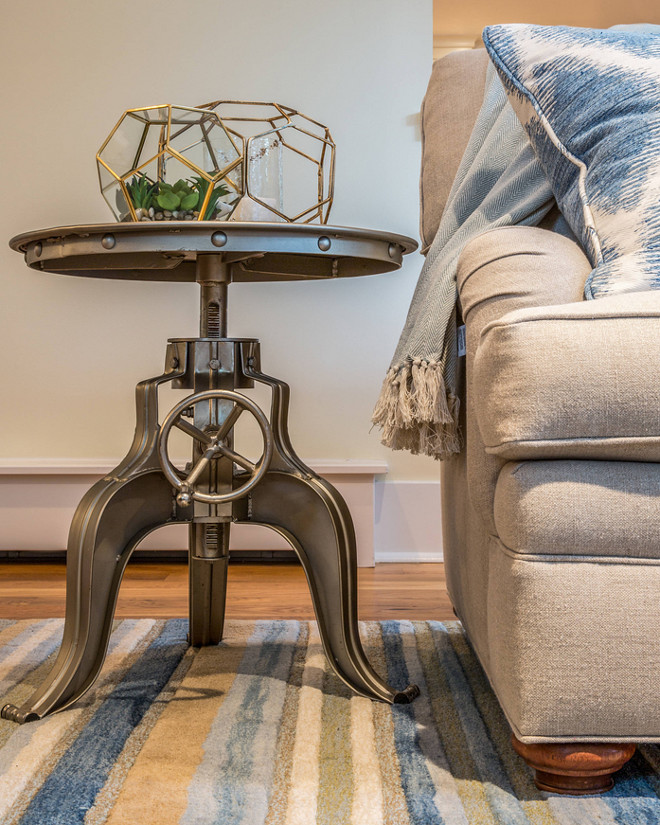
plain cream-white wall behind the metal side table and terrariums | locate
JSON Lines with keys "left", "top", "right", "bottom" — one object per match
{"left": 0, "top": 0, "right": 437, "bottom": 480}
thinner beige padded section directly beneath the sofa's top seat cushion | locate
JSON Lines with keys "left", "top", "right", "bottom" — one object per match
{"left": 495, "top": 461, "right": 660, "bottom": 560}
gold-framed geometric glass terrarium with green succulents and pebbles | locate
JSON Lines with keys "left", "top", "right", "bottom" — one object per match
{"left": 96, "top": 104, "right": 245, "bottom": 221}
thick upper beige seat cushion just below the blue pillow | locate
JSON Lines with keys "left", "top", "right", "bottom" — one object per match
{"left": 473, "top": 291, "right": 660, "bottom": 461}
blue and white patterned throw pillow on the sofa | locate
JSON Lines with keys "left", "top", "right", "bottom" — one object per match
{"left": 483, "top": 25, "right": 660, "bottom": 298}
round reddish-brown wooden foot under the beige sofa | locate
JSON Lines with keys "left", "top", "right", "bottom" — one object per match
{"left": 511, "top": 734, "right": 635, "bottom": 796}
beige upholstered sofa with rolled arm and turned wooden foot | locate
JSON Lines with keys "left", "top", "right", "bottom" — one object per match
{"left": 422, "top": 50, "right": 660, "bottom": 793}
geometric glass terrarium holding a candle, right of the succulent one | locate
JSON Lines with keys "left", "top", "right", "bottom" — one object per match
{"left": 199, "top": 100, "right": 335, "bottom": 223}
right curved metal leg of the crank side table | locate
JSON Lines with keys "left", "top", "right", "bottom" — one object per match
{"left": 244, "top": 358, "right": 419, "bottom": 704}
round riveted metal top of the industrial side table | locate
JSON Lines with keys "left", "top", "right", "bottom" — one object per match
{"left": 9, "top": 221, "right": 417, "bottom": 281}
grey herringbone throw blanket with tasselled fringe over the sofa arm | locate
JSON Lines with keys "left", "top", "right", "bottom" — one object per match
{"left": 373, "top": 64, "right": 554, "bottom": 459}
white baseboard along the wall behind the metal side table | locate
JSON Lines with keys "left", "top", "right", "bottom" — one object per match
{"left": 0, "top": 459, "right": 442, "bottom": 567}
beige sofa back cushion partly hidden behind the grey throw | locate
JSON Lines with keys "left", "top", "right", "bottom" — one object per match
{"left": 420, "top": 49, "right": 488, "bottom": 254}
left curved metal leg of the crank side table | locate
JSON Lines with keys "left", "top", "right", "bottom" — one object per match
{"left": 2, "top": 470, "right": 172, "bottom": 723}
